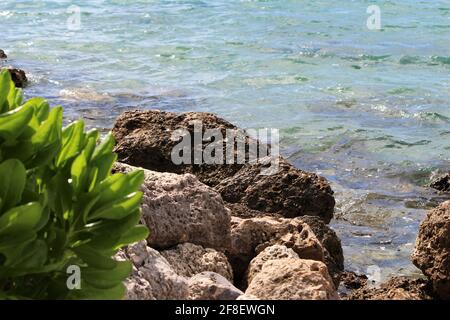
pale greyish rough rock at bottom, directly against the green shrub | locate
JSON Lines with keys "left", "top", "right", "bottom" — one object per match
{"left": 119, "top": 241, "right": 189, "bottom": 300}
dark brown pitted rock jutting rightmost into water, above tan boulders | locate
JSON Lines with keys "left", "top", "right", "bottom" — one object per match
{"left": 216, "top": 158, "right": 335, "bottom": 223}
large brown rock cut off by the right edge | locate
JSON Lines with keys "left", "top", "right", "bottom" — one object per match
{"left": 412, "top": 201, "right": 450, "bottom": 299}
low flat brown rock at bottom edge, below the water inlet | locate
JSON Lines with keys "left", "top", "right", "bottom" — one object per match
{"left": 347, "top": 277, "right": 432, "bottom": 300}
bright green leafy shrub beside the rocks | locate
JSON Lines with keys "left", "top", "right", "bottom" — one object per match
{"left": 0, "top": 71, "right": 148, "bottom": 299}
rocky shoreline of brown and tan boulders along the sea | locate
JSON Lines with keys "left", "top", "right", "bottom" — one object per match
{"left": 4, "top": 50, "right": 450, "bottom": 300}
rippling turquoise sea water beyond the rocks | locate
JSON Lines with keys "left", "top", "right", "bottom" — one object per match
{"left": 0, "top": 0, "right": 450, "bottom": 278}
